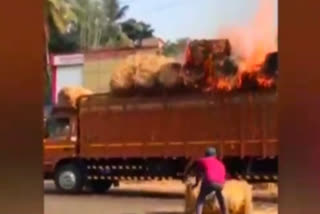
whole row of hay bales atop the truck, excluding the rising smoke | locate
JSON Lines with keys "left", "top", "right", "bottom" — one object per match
{"left": 110, "top": 39, "right": 278, "bottom": 95}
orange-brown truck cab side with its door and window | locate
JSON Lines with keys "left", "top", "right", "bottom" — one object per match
{"left": 44, "top": 117, "right": 76, "bottom": 172}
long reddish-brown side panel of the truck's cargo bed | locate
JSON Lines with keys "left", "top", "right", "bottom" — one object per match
{"left": 79, "top": 93, "right": 278, "bottom": 158}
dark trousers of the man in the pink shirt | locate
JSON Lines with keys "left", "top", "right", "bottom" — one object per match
{"left": 196, "top": 181, "right": 228, "bottom": 214}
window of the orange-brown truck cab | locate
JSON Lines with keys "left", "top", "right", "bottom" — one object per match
{"left": 47, "top": 118, "right": 70, "bottom": 140}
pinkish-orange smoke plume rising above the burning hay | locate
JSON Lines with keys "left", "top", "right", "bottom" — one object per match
{"left": 219, "top": 0, "right": 277, "bottom": 70}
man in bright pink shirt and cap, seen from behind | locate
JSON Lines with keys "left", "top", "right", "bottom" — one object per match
{"left": 187, "top": 147, "right": 228, "bottom": 214}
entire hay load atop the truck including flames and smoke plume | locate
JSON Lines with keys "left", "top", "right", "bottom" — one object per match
{"left": 111, "top": 0, "right": 279, "bottom": 97}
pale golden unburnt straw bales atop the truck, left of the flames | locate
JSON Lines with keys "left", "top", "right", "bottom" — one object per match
{"left": 110, "top": 54, "right": 182, "bottom": 93}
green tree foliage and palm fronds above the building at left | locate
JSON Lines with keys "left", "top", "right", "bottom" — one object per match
{"left": 47, "top": 0, "right": 154, "bottom": 53}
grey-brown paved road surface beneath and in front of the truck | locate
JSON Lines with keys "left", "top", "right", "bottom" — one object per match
{"left": 45, "top": 182, "right": 277, "bottom": 214}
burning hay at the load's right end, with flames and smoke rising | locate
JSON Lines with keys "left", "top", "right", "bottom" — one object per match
{"left": 214, "top": 0, "right": 278, "bottom": 91}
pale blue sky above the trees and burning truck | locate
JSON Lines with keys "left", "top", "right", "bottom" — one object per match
{"left": 120, "top": 0, "right": 278, "bottom": 41}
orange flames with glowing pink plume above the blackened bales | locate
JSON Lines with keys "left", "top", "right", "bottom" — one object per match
{"left": 217, "top": 0, "right": 277, "bottom": 90}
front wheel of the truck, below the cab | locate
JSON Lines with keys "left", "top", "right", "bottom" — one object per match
{"left": 54, "top": 164, "right": 85, "bottom": 193}
